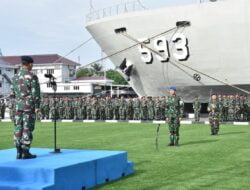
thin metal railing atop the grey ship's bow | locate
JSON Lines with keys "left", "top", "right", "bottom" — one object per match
{"left": 86, "top": 0, "right": 146, "bottom": 23}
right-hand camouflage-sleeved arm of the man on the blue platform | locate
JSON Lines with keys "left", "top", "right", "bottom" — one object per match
{"left": 31, "top": 75, "right": 41, "bottom": 109}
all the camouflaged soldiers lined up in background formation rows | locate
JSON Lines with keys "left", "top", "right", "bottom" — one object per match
{"left": 21, "top": 95, "right": 246, "bottom": 121}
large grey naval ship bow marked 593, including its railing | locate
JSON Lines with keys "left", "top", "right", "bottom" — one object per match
{"left": 86, "top": 0, "right": 250, "bottom": 102}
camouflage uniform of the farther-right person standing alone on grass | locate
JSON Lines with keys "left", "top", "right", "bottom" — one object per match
{"left": 207, "top": 100, "right": 220, "bottom": 135}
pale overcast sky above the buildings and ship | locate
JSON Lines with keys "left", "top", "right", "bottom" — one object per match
{"left": 0, "top": 0, "right": 198, "bottom": 66}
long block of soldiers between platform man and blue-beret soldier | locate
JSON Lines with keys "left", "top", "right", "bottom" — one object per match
{"left": 32, "top": 96, "right": 185, "bottom": 120}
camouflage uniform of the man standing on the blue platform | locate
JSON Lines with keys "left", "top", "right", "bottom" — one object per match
{"left": 12, "top": 67, "right": 40, "bottom": 152}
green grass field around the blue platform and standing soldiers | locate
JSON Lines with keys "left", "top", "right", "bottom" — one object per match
{"left": 0, "top": 123, "right": 250, "bottom": 190}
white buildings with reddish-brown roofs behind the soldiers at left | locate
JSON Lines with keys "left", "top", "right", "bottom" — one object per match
{"left": 1, "top": 54, "right": 136, "bottom": 96}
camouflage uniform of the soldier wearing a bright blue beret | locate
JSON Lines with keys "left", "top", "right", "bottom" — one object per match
{"left": 166, "top": 95, "right": 184, "bottom": 146}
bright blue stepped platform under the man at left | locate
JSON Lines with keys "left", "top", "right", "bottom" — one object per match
{"left": 0, "top": 148, "right": 133, "bottom": 190}
